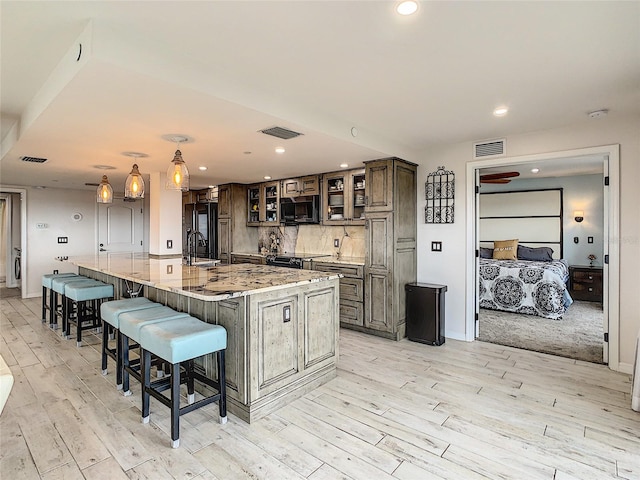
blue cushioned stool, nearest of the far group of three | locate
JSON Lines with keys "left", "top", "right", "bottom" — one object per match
{"left": 63, "top": 281, "right": 113, "bottom": 346}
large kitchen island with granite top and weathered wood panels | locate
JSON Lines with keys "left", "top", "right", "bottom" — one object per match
{"left": 69, "top": 253, "right": 339, "bottom": 422}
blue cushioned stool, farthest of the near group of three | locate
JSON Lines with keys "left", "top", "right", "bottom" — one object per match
{"left": 100, "top": 297, "right": 162, "bottom": 390}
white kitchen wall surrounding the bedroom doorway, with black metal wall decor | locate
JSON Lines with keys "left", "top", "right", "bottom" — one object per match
{"left": 417, "top": 114, "right": 640, "bottom": 368}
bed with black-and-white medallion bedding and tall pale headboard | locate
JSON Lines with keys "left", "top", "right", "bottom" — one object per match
{"left": 478, "top": 188, "right": 573, "bottom": 320}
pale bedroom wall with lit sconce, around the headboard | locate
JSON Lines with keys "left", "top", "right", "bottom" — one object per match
{"left": 480, "top": 175, "right": 604, "bottom": 266}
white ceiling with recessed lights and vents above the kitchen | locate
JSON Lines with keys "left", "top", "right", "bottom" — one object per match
{"left": 0, "top": 0, "right": 640, "bottom": 191}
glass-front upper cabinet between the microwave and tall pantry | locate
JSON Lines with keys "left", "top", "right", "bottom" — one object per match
{"left": 322, "top": 169, "right": 365, "bottom": 225}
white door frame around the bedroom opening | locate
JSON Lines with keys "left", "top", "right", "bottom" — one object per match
{"left": 466, "top": 145, "right": 619, "bottom": 370}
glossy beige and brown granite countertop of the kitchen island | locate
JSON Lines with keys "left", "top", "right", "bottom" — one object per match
{"left": 68, "top": 253, "right": 339, "bottom": 301}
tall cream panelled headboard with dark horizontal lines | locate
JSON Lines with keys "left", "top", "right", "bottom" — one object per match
{"left": 478, "top": 188, "right": 564, "bottom": 258}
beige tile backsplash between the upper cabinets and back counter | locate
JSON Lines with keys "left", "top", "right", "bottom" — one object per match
{"left": 257, "top": 225, "right": 365, "bottom": 257}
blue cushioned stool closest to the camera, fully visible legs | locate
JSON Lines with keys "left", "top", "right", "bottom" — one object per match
{"left": 139, "top": 316, "right": 227, "bottom": 448}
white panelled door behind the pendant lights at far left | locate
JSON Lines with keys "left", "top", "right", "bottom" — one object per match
{"left": 98, "top": 198, "right": 144, "bottom": 253}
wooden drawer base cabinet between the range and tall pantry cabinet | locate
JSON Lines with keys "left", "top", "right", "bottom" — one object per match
{"left": 311, "top": 261, "right": 364, "bottom": 327}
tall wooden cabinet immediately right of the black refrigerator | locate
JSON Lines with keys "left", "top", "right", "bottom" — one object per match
{"left": 217, "top": 183, "right": 258, "bottom": 264}
